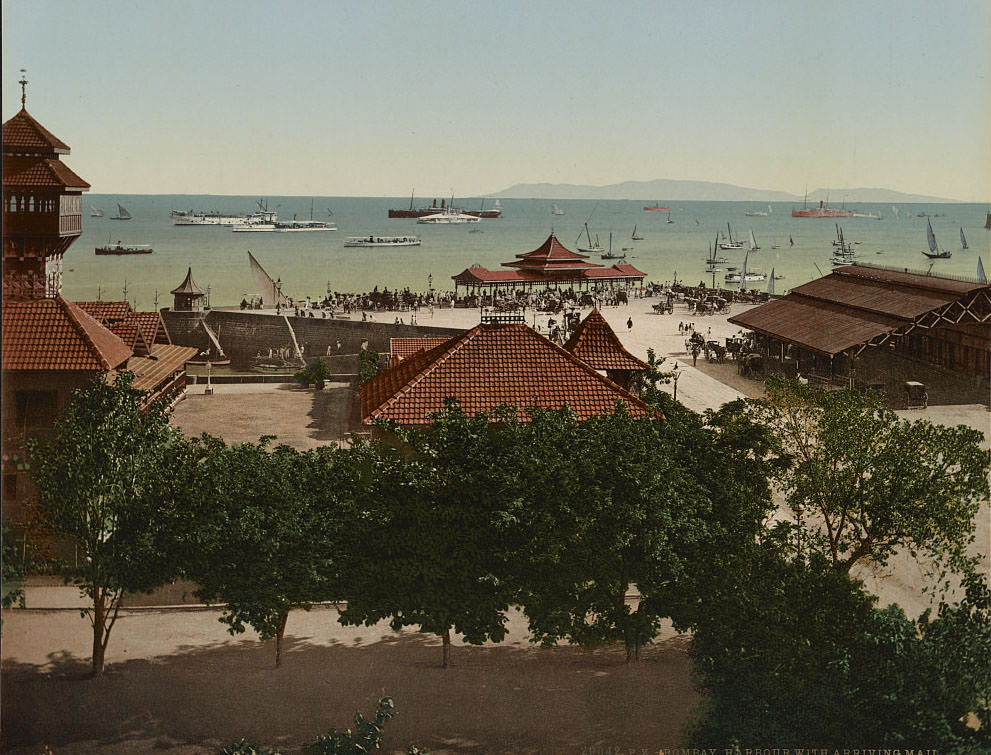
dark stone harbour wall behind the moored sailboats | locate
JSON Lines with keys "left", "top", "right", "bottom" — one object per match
{"left": 162, "top": 309, "right": 464, "bottom": 367}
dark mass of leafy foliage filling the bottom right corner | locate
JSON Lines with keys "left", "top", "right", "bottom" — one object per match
{"left": 688, "top": 547, "right": 991, "bottom": 755}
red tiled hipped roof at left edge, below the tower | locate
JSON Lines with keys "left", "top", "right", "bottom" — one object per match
{"left": 2, "top": 296, "right": 131, "bottom": 371}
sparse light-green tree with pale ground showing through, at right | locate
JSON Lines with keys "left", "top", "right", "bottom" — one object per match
{"left": 750, "top": 380, "right": 988, "bottom": 572}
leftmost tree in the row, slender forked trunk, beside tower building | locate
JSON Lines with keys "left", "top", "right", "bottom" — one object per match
{"left": 29, "top": 372, "right": 184, "bottom": 676}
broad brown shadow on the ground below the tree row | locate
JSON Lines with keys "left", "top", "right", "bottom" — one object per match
{"left": 3, "top": 634, "right": 698, "bottom": 755}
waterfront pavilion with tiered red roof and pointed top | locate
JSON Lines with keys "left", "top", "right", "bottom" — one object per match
{"left": 452, "top": 233, "right": 647, "bottom": 292}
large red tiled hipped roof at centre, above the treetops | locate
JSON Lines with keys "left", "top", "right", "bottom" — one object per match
{"left": 361, "top": 324, "right": 649, "bottom": 425}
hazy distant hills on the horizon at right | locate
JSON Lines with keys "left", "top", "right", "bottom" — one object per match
{"left": 485, "top": 178, "right": 958, "bottom": 206}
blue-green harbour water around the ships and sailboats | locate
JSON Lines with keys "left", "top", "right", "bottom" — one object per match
{"left": 71, "top": 194, "right": 991, "bottom": 311}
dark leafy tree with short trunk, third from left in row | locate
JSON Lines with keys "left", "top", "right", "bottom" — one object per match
{"left": 340, "top": 399, "right": 519, "bottom": 668}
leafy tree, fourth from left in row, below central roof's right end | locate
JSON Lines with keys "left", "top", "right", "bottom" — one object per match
{"left": 519, "top": 404, "right": 710, "bottom": 660}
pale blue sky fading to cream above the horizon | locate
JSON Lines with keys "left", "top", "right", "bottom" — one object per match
{"left": 0, "top": 0, "right": 991, "bottom": 202}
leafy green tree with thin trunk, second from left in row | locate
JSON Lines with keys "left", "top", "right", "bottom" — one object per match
{"left": 182, "top": 435, "right": 341, "bottom": 667}
